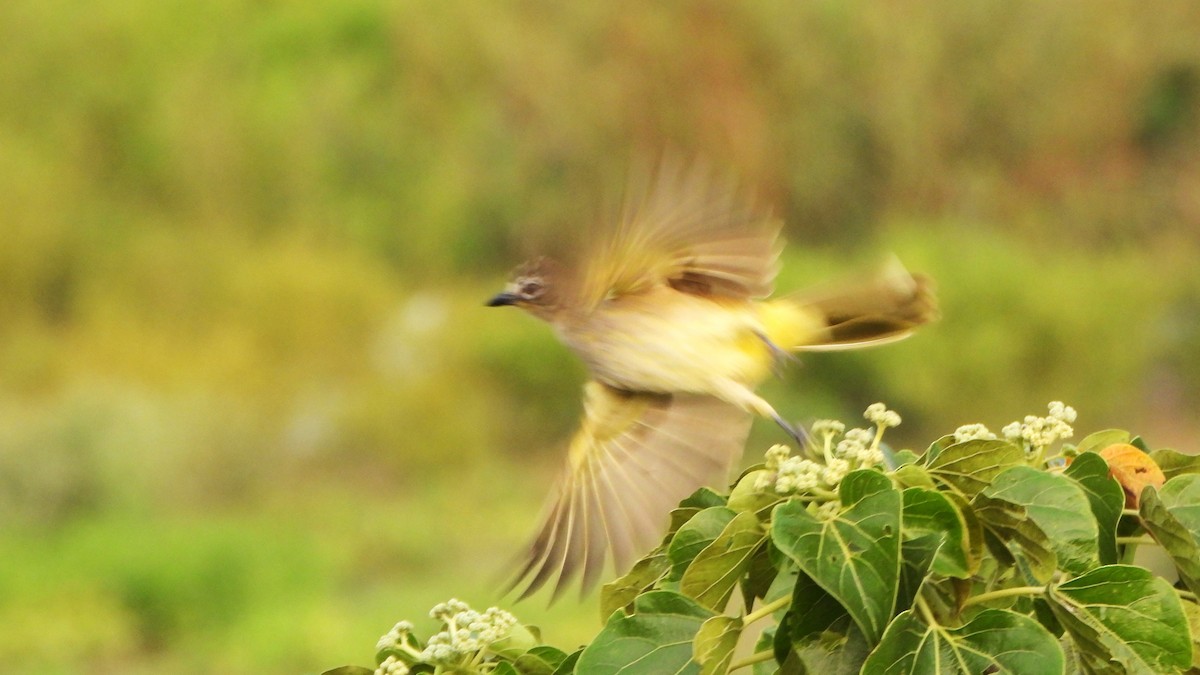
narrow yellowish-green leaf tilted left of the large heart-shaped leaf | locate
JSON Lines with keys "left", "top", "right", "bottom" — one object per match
{"left": 679, "top": 512, "right": 767, "bottom": 611}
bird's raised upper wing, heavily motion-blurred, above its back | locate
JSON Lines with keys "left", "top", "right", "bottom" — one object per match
{"left": 576, "top": 156, "right": 782, "bottom": 306}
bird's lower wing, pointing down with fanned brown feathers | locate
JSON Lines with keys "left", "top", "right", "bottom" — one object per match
{"left": 510, "top": 381, "right": 750, "bottom": 598}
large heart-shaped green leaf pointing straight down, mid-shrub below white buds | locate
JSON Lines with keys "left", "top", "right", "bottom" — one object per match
{"left": 770, "top": 471, "right": 901, "bottom": 644}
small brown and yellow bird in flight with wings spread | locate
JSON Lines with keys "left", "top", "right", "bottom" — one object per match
{"left": 486, "top": 156, "right": 938, "bottom": 602}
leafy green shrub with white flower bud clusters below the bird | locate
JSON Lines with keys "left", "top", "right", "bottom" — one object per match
{"left": 326, "top": 402, "right": 1200, "bottom": 675}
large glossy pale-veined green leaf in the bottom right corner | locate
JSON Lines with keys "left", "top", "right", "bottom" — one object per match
{"left": 1046, "top": 565, "right": 1192, "bottom": 673}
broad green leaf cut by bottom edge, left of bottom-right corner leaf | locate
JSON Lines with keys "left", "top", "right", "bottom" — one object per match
{"left": 863, "top": 609, "right": 1064, "bottom": 675}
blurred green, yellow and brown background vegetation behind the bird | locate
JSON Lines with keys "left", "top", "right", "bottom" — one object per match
{"left": 0, "top": 0, "right": 1200, "bottom": 674}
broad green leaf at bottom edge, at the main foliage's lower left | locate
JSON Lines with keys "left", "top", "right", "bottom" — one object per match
{"left": 575, "top": 591, "right": 713, "bottom": 675}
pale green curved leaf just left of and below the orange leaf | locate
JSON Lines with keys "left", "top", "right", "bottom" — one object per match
{"left": 983, "top": 466, "right": 1100, "bottom": 574}
